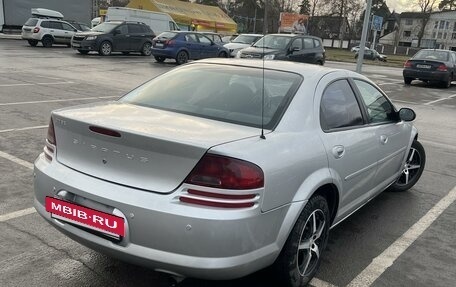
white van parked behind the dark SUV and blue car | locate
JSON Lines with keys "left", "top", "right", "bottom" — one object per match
{"left": 105, "top": 7, "right": 180, "bottom": 35}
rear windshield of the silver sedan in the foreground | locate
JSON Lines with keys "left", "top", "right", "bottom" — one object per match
{"left": 119, "top": 64, "right": 302, "bottom": 130}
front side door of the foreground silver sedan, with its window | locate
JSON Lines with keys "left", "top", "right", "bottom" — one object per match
{"left": 353, "top": 79, "right": 412, "bottom": 193}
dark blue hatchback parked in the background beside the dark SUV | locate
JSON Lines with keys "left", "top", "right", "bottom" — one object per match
{"left": 152, "top": 31, "right": 228, "bottom": 65}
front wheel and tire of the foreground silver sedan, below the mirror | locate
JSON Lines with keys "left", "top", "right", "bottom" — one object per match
{"left": 388, "top": 140, "right": 426, "bottom": 192}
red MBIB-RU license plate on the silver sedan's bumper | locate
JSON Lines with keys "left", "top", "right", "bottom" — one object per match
{"left": 46, "top": 196, "right": 125, "bottom": 241}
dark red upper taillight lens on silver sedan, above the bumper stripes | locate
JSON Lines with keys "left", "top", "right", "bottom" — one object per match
{"left": 185, "top": 154, "right": 264, "bottom": 189}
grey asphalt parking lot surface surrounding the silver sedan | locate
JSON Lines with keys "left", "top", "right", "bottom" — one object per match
{"left": 0, "top": 39, "right": 456, "bottom": 287}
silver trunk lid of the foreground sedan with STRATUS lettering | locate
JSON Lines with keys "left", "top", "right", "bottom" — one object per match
{"left": 52, "top": 102, "right": 259, "bottom": 193}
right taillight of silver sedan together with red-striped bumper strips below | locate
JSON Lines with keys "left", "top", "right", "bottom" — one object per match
{"left": 179, "top": 154, "right": 264, "bottom": 208}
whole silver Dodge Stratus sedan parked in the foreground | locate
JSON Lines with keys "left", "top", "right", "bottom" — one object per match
{"left": 34, "top": 59, "right": 425, "bottom": 286}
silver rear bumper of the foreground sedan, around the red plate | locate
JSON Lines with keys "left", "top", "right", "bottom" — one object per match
{"left": 34, "top": 154, "right": 302, "bottom": 279}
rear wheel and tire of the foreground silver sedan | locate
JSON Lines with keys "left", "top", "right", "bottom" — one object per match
{"left": 273, "top": 195, "right": 330, "bottom": 287}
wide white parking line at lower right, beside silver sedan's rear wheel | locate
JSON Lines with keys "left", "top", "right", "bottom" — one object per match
{"left": 348, "top": 186, "right": 456, "bottom": 287}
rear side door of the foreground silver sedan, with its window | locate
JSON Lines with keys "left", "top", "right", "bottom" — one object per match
{"left": 315, "top": 72, "right": 378, "bottom": 218}
